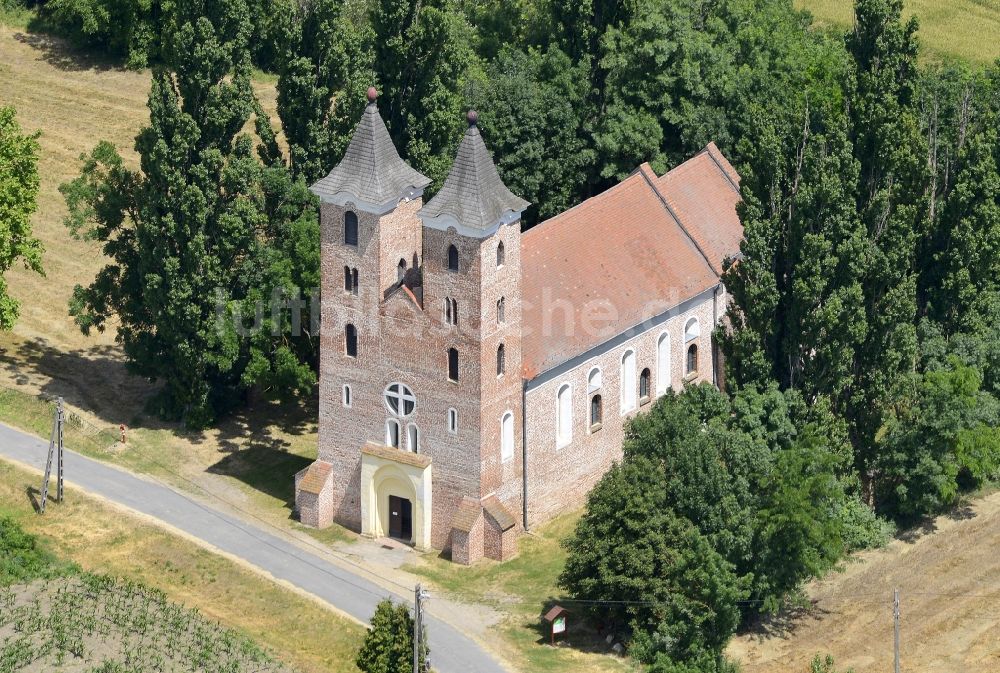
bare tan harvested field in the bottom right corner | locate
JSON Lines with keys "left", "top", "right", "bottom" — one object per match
{"left": 729, "top": 493, "right": 1000, "bottom": 673}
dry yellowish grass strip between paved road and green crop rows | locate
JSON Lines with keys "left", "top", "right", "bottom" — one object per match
{"left": 0, "top": 456, "right": 364, "bottom": 673}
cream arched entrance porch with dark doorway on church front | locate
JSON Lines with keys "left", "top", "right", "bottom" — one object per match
{"left": 361, "top": 444, "right": 432, "bottom": 551}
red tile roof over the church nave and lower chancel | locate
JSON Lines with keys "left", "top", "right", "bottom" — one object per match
{"left": 521, "top": 145, "right": 743, "bottom": 379}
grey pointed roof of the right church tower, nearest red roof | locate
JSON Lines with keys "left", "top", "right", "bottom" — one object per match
{"left": 417, "top": 110, "right": 530, "bottom": 238}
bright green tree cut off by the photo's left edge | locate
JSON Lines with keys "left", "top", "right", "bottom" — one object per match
{"left": 0, "top": 106, "right": 43, "bottom": 330}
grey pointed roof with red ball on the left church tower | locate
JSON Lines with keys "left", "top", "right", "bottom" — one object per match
{"left": 310, "top": 87, "right": 431, "bottom": 214}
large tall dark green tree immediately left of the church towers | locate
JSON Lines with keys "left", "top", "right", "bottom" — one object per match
{"left": 63, "top": 0, "right": 318, "bottom": 427}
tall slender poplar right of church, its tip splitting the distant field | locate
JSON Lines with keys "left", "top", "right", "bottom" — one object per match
{"left": 846, "top": 0, "right": 926, "bottom": 493}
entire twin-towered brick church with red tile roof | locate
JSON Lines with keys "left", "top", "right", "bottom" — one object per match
{"left": 295, "top": 89, "right": 743, "bottom": 563}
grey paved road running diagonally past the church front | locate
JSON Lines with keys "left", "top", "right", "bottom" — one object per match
{"left": 0, "top": 424, "right": 505, "bottom": 673}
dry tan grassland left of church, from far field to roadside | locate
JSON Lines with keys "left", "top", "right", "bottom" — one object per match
{"left": 0, "top": 24, "right": 350, "bottom": 541}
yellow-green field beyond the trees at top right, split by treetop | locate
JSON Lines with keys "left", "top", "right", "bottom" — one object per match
{"left": 795, "top": 0, "right": 1000, "bottom": 63}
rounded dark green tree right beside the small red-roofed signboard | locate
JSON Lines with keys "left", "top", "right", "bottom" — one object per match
{"left": 559, "top": 460, "right": 746, "bottom": 661}
